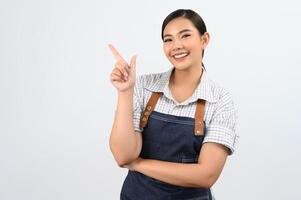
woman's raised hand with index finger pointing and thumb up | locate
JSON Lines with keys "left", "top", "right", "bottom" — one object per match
{"left": 109, "top": 44, "right": 136, "bottom": 92}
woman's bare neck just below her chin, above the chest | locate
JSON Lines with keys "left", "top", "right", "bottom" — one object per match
{"left": 170, "top": 65, "right": 203, "bottom": 88}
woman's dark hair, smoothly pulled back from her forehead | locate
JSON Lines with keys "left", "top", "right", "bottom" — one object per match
{"left": 161, "top": 9, "right": 207, "bottom": 66}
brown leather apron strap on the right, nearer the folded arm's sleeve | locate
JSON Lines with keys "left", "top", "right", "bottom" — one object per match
{"left": 194, "top": 99, "right": 206, "bottom": 135}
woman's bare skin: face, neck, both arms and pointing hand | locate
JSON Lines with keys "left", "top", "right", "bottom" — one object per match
{"left": 110, "top": 17, "right": 228, "bottom": 188}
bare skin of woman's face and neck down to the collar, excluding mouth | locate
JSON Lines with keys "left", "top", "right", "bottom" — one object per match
{"left": 163, "top": 18, "right": 209, "bottom": 102}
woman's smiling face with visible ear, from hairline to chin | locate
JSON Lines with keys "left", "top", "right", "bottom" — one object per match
{"left": 163, "top": 17, "right": 209, "bottom": 70}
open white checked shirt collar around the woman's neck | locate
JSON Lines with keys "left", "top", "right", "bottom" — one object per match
{"left": 146, "top": 67, "right": 217, "bottom": 105}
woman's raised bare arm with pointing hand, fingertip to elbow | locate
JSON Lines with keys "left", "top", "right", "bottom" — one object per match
{"left": 109, "top": 45, "right": 142, "bottom": 166}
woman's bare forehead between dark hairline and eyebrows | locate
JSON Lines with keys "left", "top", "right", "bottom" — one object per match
{"left": 163, "top": 17, "right": 197, "bottom": 35}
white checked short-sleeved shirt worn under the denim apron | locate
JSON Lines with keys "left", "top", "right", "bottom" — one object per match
{"left": 134, "top": 68, "right": 239, "bottom": 155}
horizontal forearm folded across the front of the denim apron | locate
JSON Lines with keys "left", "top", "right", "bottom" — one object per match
{"left": 134, "top": 159, "right": 215, "bottom": 188}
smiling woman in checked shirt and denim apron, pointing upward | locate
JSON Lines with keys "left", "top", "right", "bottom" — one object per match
{"left": 109, "top": 9, "right": 237, "bottom": 200}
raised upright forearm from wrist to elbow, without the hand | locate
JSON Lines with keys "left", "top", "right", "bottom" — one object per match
{"left": 110, "top": 90, "right": 138, "bottom": 165}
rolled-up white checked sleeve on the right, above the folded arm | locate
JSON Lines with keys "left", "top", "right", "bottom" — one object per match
{"left": 204, "top": 91, "right": 239, "bottom": 155}
